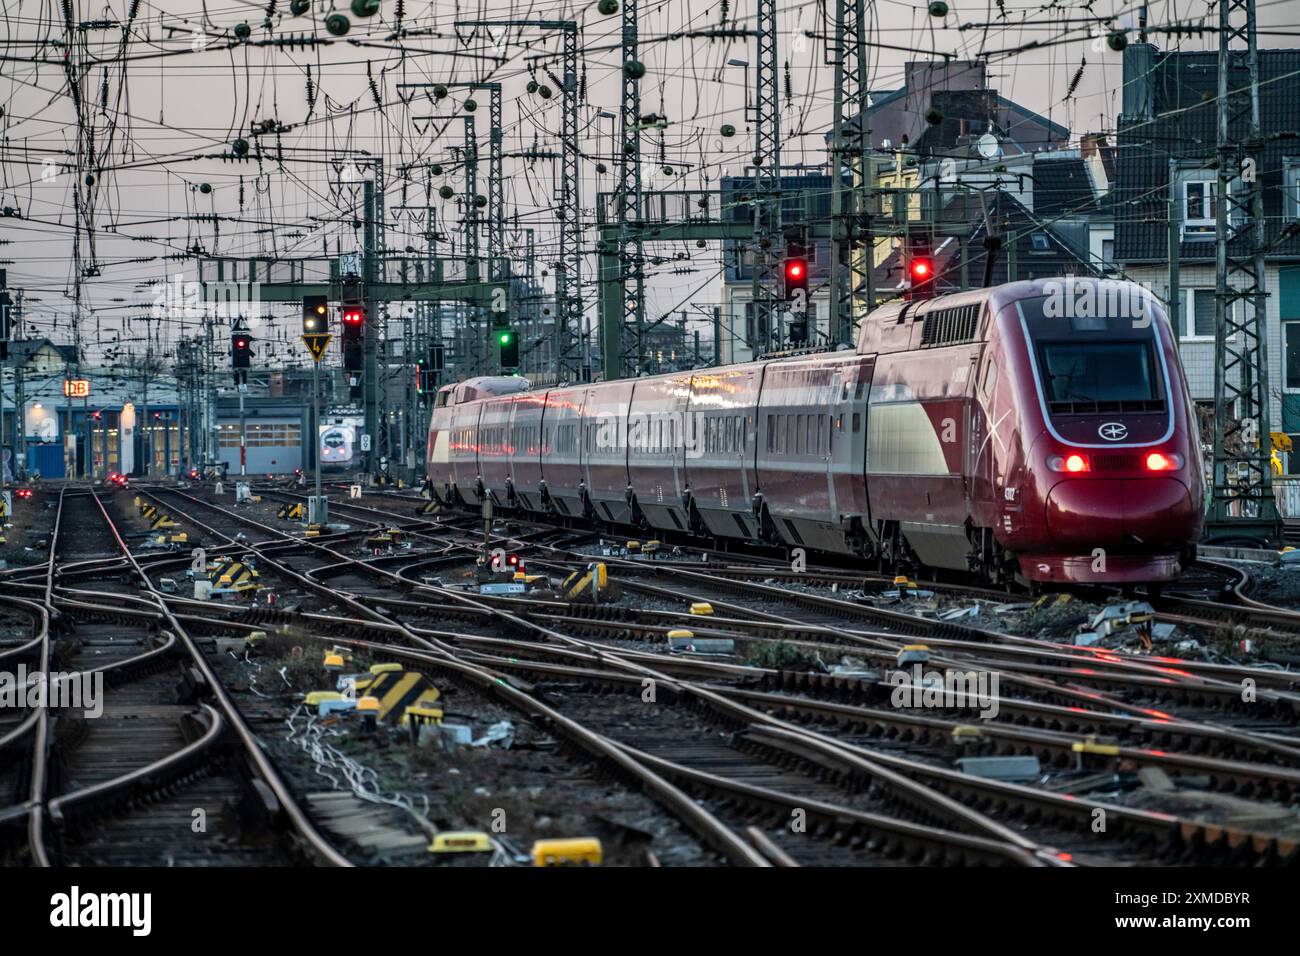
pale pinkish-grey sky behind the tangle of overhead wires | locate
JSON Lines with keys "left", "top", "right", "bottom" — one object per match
{"left": 0, "top": 0, "right": 1297, "bottom": 363}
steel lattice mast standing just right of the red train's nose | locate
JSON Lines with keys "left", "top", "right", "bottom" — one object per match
{"left": 1206, "top": 0, "right": 1279, "bottom": 540}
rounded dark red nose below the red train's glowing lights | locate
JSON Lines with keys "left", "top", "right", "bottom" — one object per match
{"left": 1047, "top": 477, "right": 1199, "bottom": 546}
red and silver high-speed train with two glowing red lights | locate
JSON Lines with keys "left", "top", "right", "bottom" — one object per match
{"left": 428, "top": 278, "right": 1204, "bottom": 584}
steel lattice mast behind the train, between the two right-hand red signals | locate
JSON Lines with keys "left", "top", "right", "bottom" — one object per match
{"left": 827, "top": 0, "right": 875, "bottom": 345}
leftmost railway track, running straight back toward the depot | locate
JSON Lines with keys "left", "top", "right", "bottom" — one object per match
{"left": 0, "top": 489, "right": 347, "bottom": 865}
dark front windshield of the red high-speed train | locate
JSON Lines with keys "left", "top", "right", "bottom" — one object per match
{"left": 1039, "top": 339, "right": 1157, "bottom": 403}
